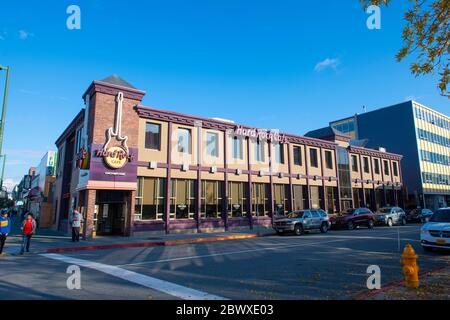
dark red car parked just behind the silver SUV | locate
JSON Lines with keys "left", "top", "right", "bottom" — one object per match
{"left": 330, "top": 208, "right": 375, "bottom": 230}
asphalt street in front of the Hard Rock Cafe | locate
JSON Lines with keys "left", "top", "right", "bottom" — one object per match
{"left": 0, "top": 224, "right": 450, "bottom": 300}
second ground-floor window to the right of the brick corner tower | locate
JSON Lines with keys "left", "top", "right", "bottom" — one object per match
{"left": 170, "top": 179, "right": 196, "bottom": 219}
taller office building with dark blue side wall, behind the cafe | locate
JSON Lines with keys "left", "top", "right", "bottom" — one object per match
{"left": 330, "top": 101, "right": 450, "bottom": 210}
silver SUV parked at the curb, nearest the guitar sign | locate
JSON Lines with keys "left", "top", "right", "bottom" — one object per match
{"left": 273, "top": 209, "right": 330, "bottom": 236}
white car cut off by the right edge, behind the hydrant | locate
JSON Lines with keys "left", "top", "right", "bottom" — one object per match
{"left": 420, "top": 208, "right": 450, "bottom": 251}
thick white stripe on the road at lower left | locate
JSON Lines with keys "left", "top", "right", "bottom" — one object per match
{"left": 41, "top": 253, "right": 228, "bottom": 300}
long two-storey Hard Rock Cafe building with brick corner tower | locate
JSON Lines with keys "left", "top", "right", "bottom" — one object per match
{"left": 53, "top": 76, "right": 402, "bottom": 237}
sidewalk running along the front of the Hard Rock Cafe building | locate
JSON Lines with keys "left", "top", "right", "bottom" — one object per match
{"left": 1, "top": 219, "right": 275, "bottom": 255}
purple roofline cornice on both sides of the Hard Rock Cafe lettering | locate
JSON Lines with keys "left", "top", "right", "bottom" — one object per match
{"left": 135, "top": 105, "right": 337, "bottom": 149}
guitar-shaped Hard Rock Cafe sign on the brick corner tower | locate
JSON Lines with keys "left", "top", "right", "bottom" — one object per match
{"left": 94, "top": 92, "right": 134, "bottom": 169}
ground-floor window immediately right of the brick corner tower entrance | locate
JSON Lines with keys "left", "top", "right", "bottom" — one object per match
{"left": 134, "top": 177, "right": 166, "bottom": 220}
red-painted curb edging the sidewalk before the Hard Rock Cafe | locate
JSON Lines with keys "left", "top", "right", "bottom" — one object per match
{"left": 46, "top": 234, "right": 265, "bottom": 253}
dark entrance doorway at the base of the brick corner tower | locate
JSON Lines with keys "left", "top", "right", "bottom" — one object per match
{"left": 97, "top": 203, "right": 125, "bottom": 235}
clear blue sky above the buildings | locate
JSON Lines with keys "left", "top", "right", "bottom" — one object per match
{"left": 0, "top": 0, "right": 450, "bottom": 189}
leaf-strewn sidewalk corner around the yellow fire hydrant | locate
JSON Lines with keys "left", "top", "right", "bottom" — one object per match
{"left": 359, "top": 266, "right": 450, "bottom": 300}
